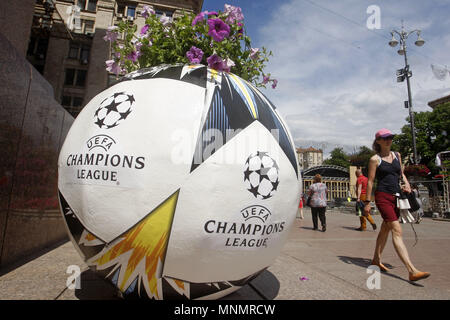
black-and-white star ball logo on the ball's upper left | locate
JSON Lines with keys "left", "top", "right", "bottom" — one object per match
{"left": 94, "top": 92, "right": 135, "bottom": 129}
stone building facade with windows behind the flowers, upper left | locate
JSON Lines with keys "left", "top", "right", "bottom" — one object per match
{"left": 27, "top": 0, "right": 203, "bottom": 117}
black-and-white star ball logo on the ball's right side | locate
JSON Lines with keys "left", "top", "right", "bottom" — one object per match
{"left": 244, "top": 151, "right": 280, "bottom": 200}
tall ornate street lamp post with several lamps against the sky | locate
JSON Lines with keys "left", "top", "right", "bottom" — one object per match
{"left": 389, "top": 25, "right": 425, "bottom": 164}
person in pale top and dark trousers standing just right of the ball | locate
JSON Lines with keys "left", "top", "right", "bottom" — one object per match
{"left": 308, "top": 174, "right": 328, "bottom": 232}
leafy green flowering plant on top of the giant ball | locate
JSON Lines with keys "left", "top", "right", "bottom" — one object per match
{"left": 105, "top": 7, "right": 277, "bottom": 88}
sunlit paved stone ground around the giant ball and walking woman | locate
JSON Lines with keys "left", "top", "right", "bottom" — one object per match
{"left": 0, "top": 209, "right": 450, "bottom": 300}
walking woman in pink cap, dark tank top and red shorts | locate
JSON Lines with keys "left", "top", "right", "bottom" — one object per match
{"left": 364, "top": 129, "right": 430, "bottom": 281}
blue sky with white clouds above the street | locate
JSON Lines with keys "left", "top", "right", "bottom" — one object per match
{"left": 203, "top": 0, "right": 450, "bottom": 157}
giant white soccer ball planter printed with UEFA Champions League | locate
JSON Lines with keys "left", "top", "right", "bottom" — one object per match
{"left": 58, "top": 65, "right": 301, "bottom": 299}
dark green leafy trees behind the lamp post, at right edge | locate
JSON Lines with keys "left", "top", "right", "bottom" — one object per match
{"left": 392, "top": 102, "right": 450, "bottom": 174}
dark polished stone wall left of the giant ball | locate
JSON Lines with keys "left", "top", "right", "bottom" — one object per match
{"left": 0, "top": 33, "right": 74, "bottom": 266}
